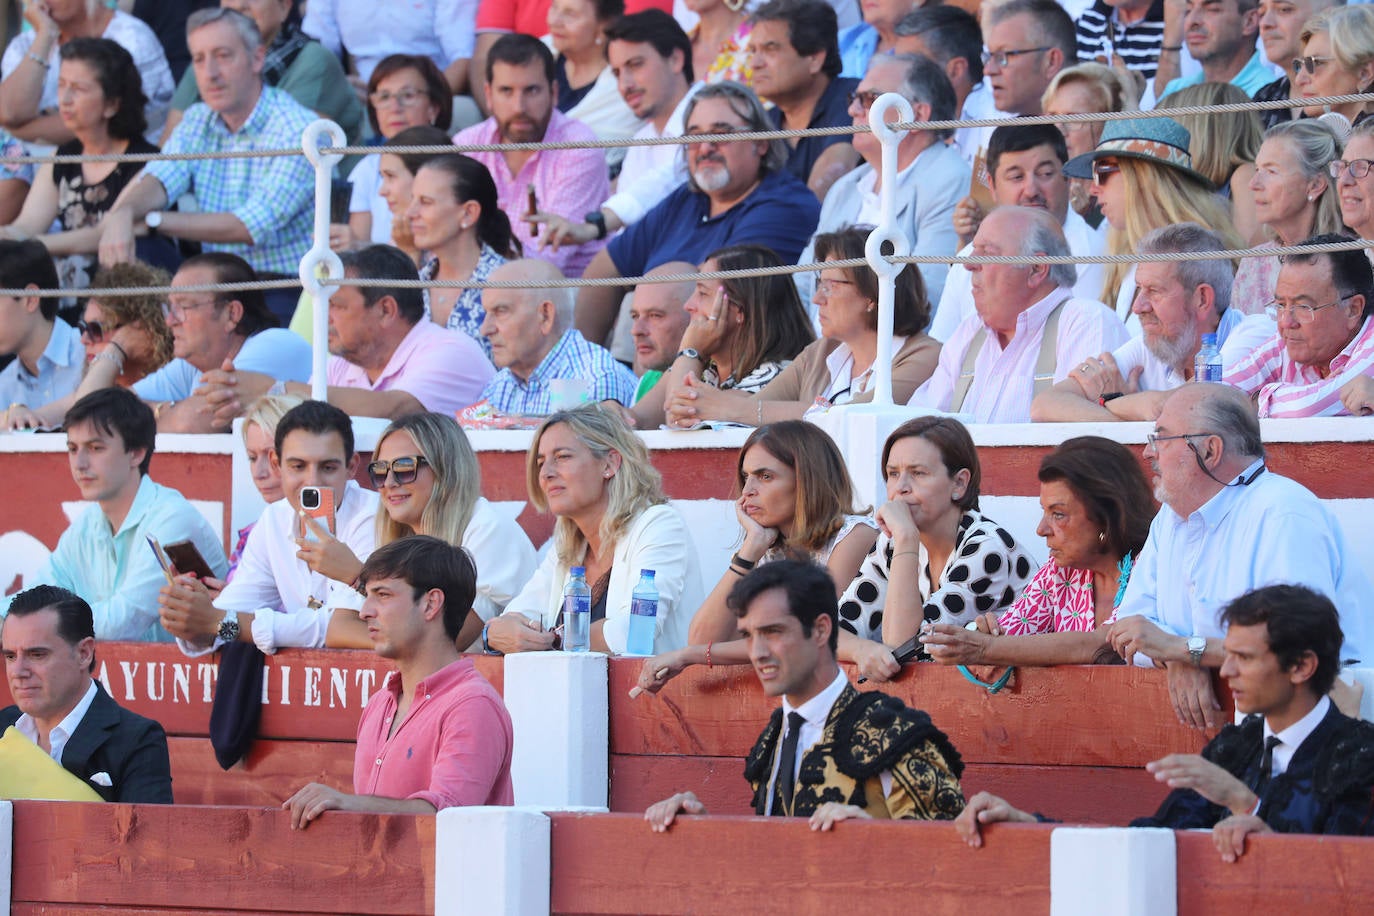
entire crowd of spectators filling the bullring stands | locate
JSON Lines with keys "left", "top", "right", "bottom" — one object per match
{"left": 0, "top": 0, "right": 1374, "bottom": 867}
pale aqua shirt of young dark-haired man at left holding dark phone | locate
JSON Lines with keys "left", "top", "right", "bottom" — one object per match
{"left": 5, "top": 477, "right": 228, "bottom": 643}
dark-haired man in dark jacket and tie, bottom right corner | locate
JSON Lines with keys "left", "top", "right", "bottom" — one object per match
{"left": 955, "top": 585, "right": 1374, "bottom": 862}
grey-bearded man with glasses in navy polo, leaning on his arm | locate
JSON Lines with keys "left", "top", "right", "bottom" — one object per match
{"left": 576, "top": 80, "right": 820, "bottom": 343}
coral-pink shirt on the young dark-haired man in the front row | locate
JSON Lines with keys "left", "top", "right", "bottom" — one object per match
{"left": 353, "top": 658, "right": 515, "bottom": 809}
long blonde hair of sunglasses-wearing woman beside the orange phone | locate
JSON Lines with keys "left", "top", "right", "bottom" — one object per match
{"left": 372, "top": 413, "right": 482, "bottom": 547}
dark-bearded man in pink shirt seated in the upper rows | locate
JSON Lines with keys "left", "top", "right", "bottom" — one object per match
{"left": 453, "top": 33, "right": 610, "bottom": 277}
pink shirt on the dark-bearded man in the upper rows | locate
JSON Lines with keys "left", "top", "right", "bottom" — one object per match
{"left": 453, "top": 108, "right": 610, "bottom": 277}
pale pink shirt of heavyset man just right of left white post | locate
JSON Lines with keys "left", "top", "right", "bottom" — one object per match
{"left": 326, "top": 317, "right": 496, "bottom": 415}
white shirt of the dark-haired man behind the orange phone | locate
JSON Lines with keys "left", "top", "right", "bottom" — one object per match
{"left": 177, "top": 481, "right": 378, "bottom": 656}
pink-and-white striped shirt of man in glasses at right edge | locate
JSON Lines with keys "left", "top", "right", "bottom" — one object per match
{"left": 1223, "top": 317, "right": 1374, "bottom": 416}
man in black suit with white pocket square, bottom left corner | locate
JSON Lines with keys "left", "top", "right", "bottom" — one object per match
{"left": 0, "top": 585, "right": 172, "bottom": 805}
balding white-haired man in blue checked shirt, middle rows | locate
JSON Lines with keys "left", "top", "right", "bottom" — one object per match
{"left": 481, "top": 258, "right": 639, "bottom": 415}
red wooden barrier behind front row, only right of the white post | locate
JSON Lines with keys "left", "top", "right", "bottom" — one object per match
{"left": 610, "top": 659, "right": 1231, "bottom": 824}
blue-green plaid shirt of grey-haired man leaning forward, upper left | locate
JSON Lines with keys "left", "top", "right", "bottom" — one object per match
{"left": 146, "top": 87, "right": 315, "bottom": 276}
